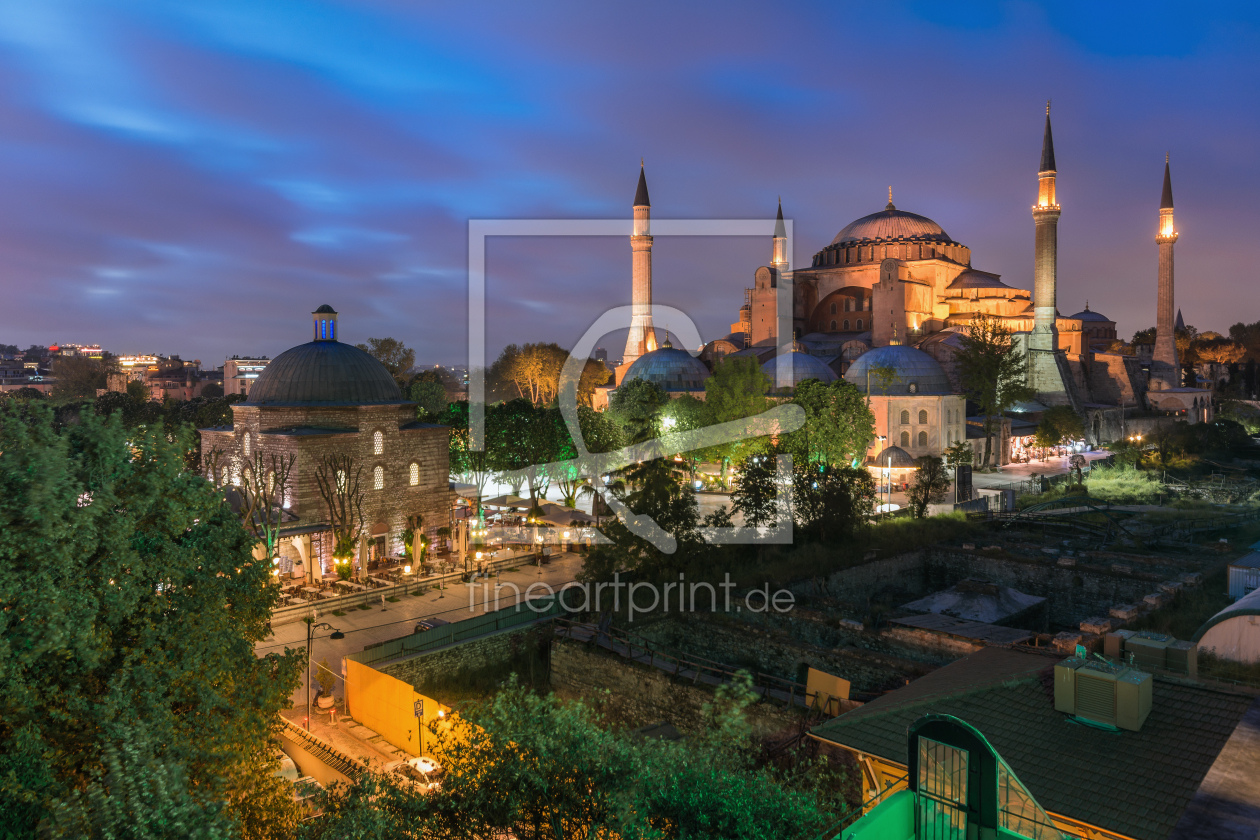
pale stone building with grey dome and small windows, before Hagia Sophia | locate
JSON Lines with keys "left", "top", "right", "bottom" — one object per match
{"left": 844, "top": 344, "right": 966, "bottom": 458}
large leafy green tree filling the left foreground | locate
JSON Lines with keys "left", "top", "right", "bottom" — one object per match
{"left": 0, "top": 403, "right": 301, "bottom": 836}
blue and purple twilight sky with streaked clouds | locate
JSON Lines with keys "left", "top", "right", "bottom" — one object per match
{"left": 0, "top": 0, "right": 1260, "bottom": 368}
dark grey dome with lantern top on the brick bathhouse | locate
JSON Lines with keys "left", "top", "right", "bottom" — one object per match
{"left": 243, "top": 304, "right": 407, "bottom": 406}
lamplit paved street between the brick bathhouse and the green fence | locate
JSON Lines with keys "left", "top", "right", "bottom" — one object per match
{"left": 255, "top": 553, "right": 582, "bottom": 707}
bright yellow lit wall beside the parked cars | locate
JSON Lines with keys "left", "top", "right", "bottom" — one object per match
{"left": 345, "top": 659, "right": 450, "bottom": 756}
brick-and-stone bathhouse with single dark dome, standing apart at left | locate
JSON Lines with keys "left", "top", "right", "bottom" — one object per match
{"left": 200, "top": 305, "right": 454, "bottom": 579}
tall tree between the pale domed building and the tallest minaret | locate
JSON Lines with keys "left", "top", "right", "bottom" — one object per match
{"left": 954, "top": 314, "right": 1033, "bottom": 467}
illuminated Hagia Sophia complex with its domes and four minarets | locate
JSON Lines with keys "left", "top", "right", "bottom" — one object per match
{"left": 596, "top": 105, "right": 1212, "bottom": 463}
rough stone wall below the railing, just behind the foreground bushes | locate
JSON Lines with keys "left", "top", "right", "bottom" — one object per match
{"left": 551, "top": 639, "right": 799, "bottom": 734}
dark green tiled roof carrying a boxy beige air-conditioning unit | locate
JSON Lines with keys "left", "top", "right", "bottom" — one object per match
{"left": 813, "top": 647, "right": 1254, "bottom": 840}
